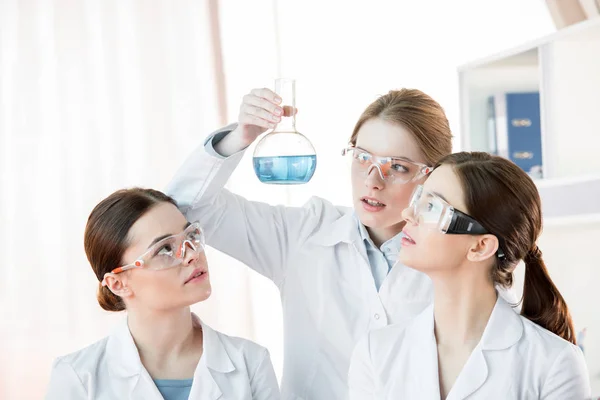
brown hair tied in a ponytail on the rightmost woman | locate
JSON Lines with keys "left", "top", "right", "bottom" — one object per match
{"left": 436, "top": 152, "right": 576, "bottom": 343}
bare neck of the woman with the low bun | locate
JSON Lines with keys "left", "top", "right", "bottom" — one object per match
{"left": 127, "top": 307, "right": 202, "bottom": 364}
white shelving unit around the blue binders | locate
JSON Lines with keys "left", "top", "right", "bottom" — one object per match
{"left": 459, "top": 18, "right": 600, "bottom": 225}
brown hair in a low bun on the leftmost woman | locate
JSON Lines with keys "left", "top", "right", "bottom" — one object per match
{"left": 83, "top": 188, "right": 177, "bottom": 311}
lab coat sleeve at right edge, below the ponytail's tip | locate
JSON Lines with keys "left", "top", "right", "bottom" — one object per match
{"left": 540, "top": 346, "right": 591, "bottom": 400}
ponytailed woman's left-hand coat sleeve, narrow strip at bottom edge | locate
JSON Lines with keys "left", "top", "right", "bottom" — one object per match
{"left": 348, "top": 335, "right": 380, "bottom": 400}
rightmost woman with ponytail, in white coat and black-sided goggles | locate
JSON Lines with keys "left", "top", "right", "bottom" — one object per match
{"left": 349, "top": 153, "right": 590, "bottom": 400}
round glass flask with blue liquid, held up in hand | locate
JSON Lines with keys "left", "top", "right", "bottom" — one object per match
{"left": 253, "top": 79, "right": 317, "bottom": 185}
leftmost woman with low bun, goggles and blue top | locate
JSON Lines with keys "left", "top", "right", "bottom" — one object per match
{"left": 46, "top": 189, "right": 280, "bottom": 400}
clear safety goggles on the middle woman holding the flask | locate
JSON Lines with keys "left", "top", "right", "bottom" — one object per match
{"left": 342, "top": 146, "right": 433, "bottom": 183}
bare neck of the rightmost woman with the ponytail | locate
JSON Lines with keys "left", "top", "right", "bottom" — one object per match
{"left": 432, "top": 266, "right": 497, "bottom": 348}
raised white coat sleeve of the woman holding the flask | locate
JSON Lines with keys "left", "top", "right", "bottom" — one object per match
{"left": 166, "top": 126, "right": 322, "bottom": 286}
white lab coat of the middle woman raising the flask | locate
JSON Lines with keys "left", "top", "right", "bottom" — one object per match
{"left": 166, "top": 125, "right": 520, "bottom": 400}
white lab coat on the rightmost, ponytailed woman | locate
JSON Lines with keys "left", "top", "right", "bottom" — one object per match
{"left": 349, "top": 297, "right": 590, "bottom": 400}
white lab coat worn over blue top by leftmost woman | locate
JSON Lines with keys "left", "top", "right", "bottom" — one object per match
{"left": 46, "top": 315, "right": 280, "bottom": 400}
